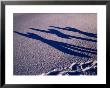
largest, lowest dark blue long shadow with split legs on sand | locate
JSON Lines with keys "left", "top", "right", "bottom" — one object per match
{"left": 14, "top": 31, "right": 97, "bottom": 58}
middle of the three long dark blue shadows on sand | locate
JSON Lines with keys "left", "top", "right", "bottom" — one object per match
{"left": 29, "top": 28, "right": 97, "bottom": 42}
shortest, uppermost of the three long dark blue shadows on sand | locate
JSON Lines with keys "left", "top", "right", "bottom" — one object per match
{"left": 49, "top": 26, "right": 97, "bottom": 38}
